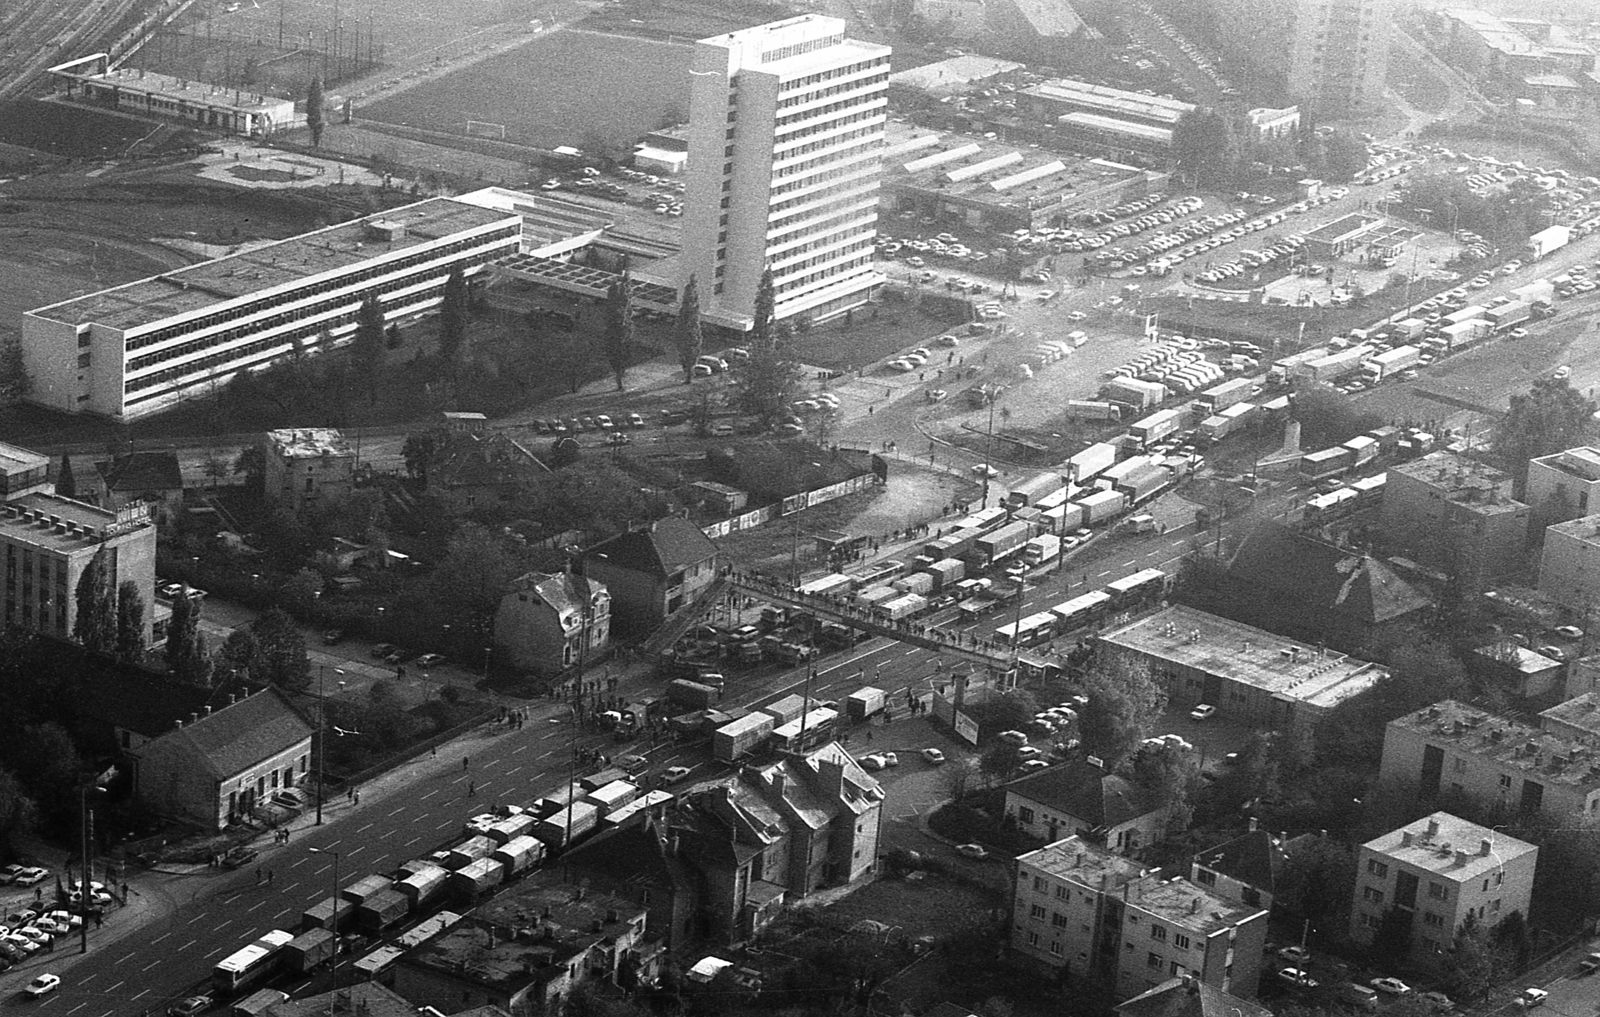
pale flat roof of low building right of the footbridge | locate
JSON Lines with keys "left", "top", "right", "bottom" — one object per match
{"left": 1101, "top": 604, "right": 1387, "bottom": 708}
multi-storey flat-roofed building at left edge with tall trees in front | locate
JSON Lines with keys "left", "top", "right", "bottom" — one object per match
{"left": 0, "top": 493, "right": 155, "bottom": 646}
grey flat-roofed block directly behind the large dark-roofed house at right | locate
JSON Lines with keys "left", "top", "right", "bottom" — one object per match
{"left": 1379, "top": 453, "right": 1528, "bottom": 590}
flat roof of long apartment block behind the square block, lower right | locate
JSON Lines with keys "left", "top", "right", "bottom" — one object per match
{"left": 1389, "top": 699, "right": 1600, "bottom": 788}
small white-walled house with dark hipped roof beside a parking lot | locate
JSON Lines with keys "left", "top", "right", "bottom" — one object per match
{"left": 1002, "top": 761, "right": 1171, "bottom": 855}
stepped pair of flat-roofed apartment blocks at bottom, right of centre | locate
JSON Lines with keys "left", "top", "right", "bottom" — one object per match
{"left": 1011, "top": 836, "right": 1267, "bottom": 999}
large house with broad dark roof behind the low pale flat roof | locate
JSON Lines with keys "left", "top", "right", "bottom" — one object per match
{"left": 1198, "top": 523, "right": 1434, "bottom": 651}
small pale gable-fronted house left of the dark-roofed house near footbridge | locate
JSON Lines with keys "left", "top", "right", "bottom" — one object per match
{"left": 494, "top": 572, "right": 611, "bottom": 675}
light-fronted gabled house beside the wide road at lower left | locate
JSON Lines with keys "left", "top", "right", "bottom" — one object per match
{"left": 134, "top": 689, "right": 312, "bottom": 830}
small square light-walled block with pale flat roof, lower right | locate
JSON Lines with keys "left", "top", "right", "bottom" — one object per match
{"left": 1350, "top": 812, "right": 1539, "bottom": 966}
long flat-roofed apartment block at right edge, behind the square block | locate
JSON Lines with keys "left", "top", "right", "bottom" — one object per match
{"left": 1379, "top": 699, "right": 1600, "bottom": 824}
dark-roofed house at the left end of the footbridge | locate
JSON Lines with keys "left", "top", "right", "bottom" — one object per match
{"left": 581, "top": 516, "right": 717, "bottom": 633}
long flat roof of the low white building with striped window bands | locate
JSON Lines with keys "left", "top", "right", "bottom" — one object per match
{"left": 29, "top": 198, "right": 509, "bottom": 329}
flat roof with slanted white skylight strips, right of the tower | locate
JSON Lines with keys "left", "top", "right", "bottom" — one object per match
{"left": 883, "top": 122, "right": 1144, "bottom": 208}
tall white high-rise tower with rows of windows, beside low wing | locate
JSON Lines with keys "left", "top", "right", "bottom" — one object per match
{"left": 680, "top": 14, "right": 890, "bottom": 329}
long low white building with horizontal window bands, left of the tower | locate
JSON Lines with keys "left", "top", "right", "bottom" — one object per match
{"left": 22, "top": 198, "right": 518, "bottom": 421}
